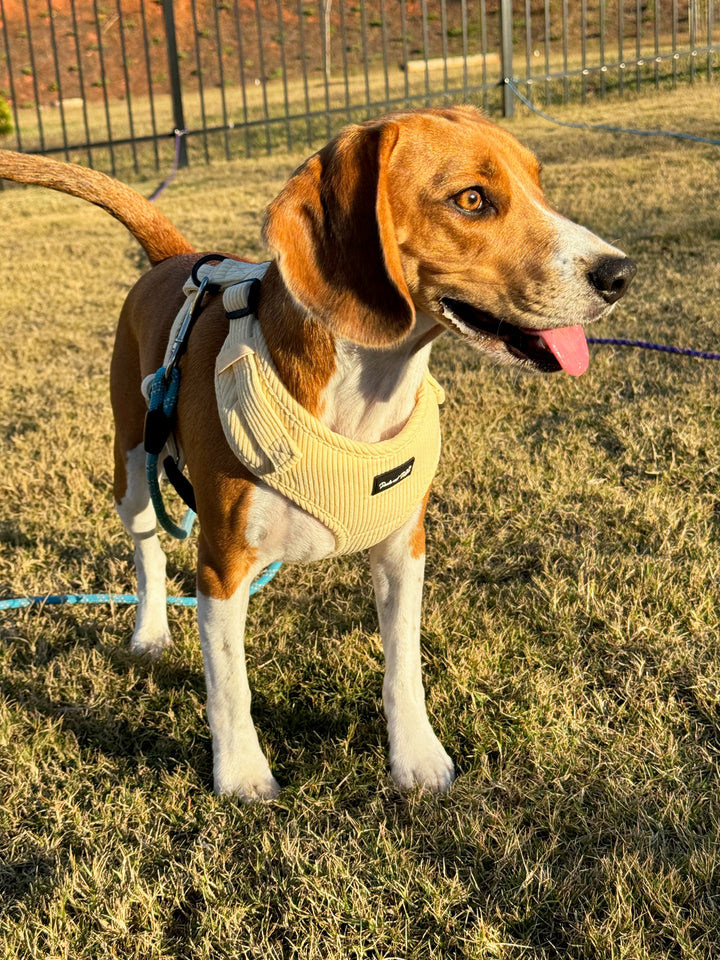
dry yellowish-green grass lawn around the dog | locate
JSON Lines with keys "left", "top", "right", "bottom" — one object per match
{"left": 0, "top": 84, "right": 720, "bottom": 960}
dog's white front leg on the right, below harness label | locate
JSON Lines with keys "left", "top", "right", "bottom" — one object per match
{"left": 370, "top": 507, "right": 455, "bottom": 793}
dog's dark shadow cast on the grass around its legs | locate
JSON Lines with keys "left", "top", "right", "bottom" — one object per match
{"left": 0, "top": 572, "right": 384, "bottom": 789}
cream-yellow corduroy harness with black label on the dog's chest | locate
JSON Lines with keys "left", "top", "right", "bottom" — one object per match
{"left": 156, "top": 260, "right": 444, "bottom": 555}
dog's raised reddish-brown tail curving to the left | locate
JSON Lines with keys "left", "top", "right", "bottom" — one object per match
{"left": 0, "top": 150, "right": 194, "bottom": 264}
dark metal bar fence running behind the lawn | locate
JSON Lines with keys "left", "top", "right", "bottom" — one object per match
{"left": 0, "top": 0, "right": 720, "bottom": 173}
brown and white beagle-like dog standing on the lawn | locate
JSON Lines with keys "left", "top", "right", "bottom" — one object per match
{"left": 0, "top": 106, "right": 635, "bottom": 801}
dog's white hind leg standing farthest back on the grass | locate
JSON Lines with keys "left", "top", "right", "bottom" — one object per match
{"left": 115, "top": 440, "right": 170, "bottom": 657}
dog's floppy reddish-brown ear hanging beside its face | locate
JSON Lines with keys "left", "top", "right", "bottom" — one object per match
{"left": 264, "top": 121, "right": 415, "bottom": 347}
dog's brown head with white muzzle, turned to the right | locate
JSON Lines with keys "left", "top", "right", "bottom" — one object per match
{"left": 265, "top": 107, "right": 635, "bottom": 373}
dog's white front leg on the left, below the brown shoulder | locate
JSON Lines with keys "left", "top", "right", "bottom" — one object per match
{"left": 197, "top": 540, "right": 280, "bottom": 801}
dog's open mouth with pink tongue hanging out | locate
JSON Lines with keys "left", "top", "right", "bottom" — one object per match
{"left": 440, "top": 297, "right": 590, "bottom": 377}
